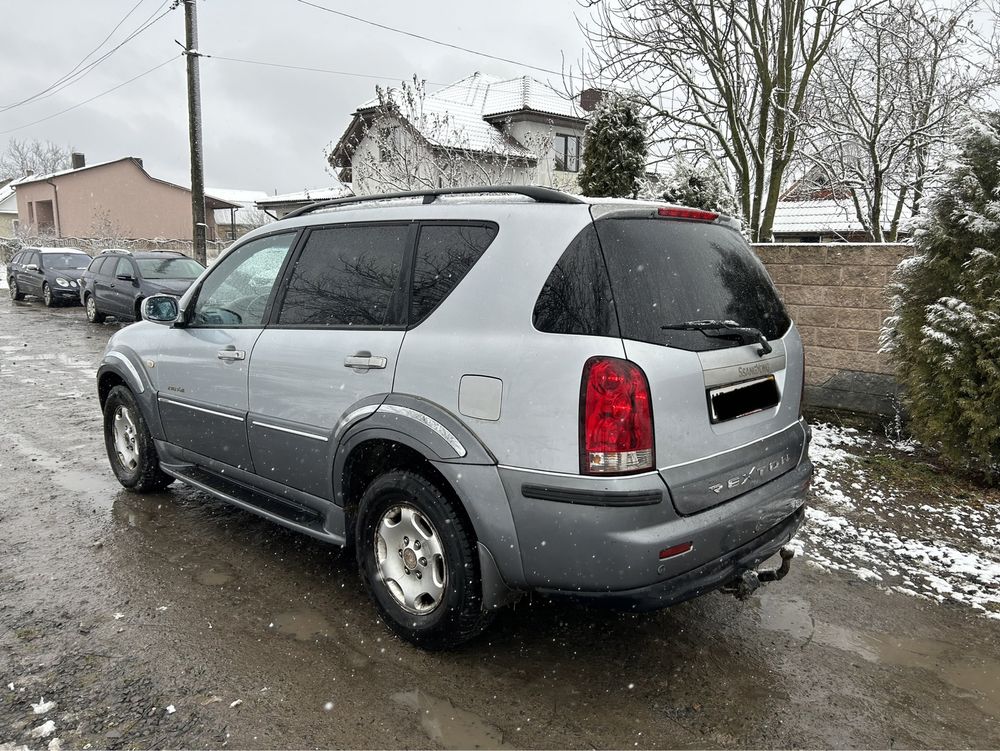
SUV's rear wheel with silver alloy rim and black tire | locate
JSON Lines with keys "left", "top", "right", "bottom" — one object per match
{"left": 355, "top": 471, "right": 492, "bottom": 650}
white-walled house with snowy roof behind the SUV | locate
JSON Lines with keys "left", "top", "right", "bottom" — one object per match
{"left": 328, "top": 73, "right": 596, "bottom": 195}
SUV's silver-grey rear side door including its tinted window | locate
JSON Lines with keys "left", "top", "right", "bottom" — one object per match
{"left": 248, "top": 223, "right": 416, "bottom": 499}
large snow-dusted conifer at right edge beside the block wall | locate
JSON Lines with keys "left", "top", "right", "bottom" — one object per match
{"left": 883, "top": 113, "right": 1000, "bottom": 480}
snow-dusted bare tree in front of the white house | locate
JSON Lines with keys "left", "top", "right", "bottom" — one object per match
{"left": 326, "top": 77, "right": 552, "bottom": 195}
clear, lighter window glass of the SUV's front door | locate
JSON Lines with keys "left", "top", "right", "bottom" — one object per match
{"left": 191, "top": 233, "right": 295, "bottom": 328}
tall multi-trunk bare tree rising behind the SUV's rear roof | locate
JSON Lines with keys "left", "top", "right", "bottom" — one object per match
{"left": 582, "top": 0, "right": 846, "bottom": 240}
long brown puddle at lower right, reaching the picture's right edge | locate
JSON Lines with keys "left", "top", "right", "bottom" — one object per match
{"left": 760, "top": 594, "right": 1000, "bottom": 718}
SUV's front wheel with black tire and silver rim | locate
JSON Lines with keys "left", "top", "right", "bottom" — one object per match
{"left": 104, "top": 386, "right": 174, "bottom": 493}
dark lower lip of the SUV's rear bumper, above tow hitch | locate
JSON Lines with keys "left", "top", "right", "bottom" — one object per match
{"left": 539, "top": 505, "right": 805, "bottom": 611}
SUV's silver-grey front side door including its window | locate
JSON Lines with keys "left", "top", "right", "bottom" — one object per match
{"left": 155, "top": 232, "right": 296, "bottom": 471}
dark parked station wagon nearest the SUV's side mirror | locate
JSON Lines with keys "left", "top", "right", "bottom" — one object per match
{"left": 79, "top": 250, "right": 205, "bottom": 323}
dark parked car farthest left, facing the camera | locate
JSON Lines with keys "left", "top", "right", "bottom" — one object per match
{"left": 7, "top": 248, "right": 90, "bottom": 308}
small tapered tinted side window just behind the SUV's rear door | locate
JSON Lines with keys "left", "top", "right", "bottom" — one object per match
{"left": 410, "top": 224, "right": 497, "bottom": 325}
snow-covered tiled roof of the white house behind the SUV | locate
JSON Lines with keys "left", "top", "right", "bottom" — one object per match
{"left": 348, "top": 73, "right": 586, "bottom": 159}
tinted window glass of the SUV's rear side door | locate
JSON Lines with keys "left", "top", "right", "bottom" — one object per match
{"left": 278, "top": 224, "right": 410, "bottom": 327}
